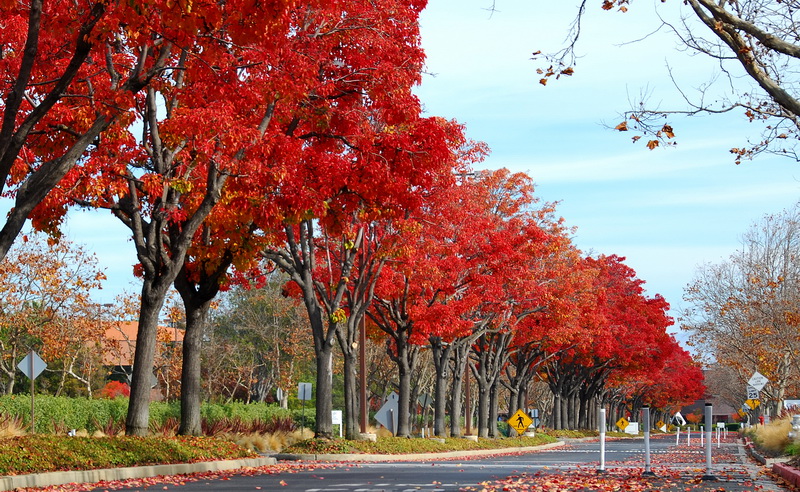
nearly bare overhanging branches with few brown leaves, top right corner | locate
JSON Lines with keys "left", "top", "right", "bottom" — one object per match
{"left": 540, "top": 0, "right": 800, "bottom": 164}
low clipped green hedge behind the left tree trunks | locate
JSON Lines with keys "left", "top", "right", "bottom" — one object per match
{"left": 0, "top": 394, "right": 308, "bottom": 434}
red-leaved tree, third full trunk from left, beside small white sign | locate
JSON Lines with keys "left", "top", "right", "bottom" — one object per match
{"left": 241, "top": 1, "right": 476, "bottom": 437}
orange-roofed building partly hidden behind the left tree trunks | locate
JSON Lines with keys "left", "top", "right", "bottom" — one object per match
{"left": 102, "top": 321, "right": 184, "bottom": 399}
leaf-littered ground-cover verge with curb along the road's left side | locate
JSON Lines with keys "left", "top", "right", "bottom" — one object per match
{"left": 0, "top": 434, "right": 563, "bottom": 490}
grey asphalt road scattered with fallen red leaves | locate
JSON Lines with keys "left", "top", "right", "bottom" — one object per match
{"left": 86, "top": 438, "right": 785, "bottom": 492}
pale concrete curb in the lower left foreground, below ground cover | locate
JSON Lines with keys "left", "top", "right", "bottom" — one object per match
{"left": 0, "top": 457, "right": 276, "bottom": 491}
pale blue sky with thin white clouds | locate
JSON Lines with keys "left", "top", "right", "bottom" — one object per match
{"left": 36, "top": 0, "right": 800, "bottom": 330}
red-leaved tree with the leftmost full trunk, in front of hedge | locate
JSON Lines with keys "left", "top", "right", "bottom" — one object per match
{"left": 24, "top": 0, "right": 306, "bottom": 434}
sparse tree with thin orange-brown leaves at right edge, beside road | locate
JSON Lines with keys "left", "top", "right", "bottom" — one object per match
{"left": 682, "top": 204, "right": 800, "bottom": 412}
